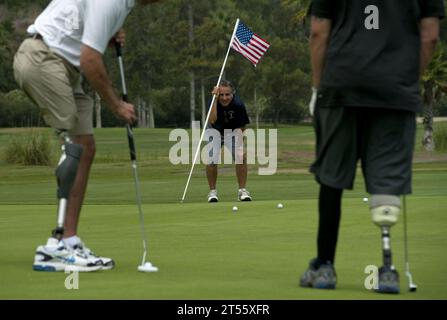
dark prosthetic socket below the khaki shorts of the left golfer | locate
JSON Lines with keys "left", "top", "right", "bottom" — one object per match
{"left": 56, "top": 143, "right": 82, "bottom": 199}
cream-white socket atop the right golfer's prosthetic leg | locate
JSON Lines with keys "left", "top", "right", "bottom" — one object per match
{"left": 370, "top": 195, "right": 401, "bottom": 227}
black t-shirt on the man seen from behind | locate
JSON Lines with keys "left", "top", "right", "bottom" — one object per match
{"left": 311, "top": 0, "right": 445, "bottom": 111}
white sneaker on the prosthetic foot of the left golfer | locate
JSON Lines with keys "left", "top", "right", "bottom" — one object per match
{"left": 33, "top": 238, "right": 101, "bottom": 272}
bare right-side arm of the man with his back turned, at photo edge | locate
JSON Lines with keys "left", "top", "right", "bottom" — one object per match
{"left": 420, "top": 17, "right": 439, "bottom": 75}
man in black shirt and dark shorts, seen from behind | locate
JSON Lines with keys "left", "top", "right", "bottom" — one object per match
{"left": 300, "top": 0, "right": 444, "bottom": 293}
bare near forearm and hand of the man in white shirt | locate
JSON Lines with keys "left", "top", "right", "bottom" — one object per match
{"left": 81, "top": 45, "right": 136, "bottom": 123}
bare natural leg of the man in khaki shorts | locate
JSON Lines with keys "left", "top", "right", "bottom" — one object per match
{"left": 64, "top": 135, "right": 96, "bottom": 238}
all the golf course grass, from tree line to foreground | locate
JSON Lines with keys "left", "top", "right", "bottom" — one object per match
{"left": 0, "top": 126, "right": 447, "bottom": 300}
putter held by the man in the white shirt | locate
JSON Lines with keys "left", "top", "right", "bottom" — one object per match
{"left": 115, "top": 42, "right": 158, "bottom": 272}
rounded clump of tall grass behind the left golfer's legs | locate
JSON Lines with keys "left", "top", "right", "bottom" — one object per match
{"left": 4, "top": 130, "right": 55, "bottom": 166}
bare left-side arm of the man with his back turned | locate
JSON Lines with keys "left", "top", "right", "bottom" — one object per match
{"left": 310, "top": 16, "right": 332, "bottom": 88}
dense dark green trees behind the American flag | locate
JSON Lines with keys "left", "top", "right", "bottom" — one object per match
{"left": 0, "top": 0, "right": 338, "bottom": 127}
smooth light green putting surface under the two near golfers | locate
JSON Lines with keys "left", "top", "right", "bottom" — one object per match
{"left": 0, "top": 197, "right": 447, "bottom": 299}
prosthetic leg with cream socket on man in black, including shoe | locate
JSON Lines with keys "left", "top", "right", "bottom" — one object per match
{"left": 370, "top": 195, "right": 401, "bottom": 293}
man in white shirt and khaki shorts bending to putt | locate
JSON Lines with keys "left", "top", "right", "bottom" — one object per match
{"left": 13, "top": 0, "right": 163, "bottom": 271}
